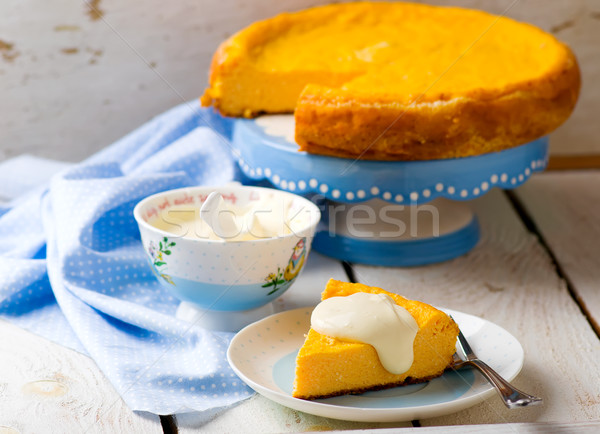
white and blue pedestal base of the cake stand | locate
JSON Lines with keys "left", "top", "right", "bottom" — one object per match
{"left": 313, "top": 198, "right": 479, "bottom": 266}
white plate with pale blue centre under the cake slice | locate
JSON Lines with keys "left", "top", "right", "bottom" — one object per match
{"left": 227, "top": 307, "right": 524, "bottom": 422}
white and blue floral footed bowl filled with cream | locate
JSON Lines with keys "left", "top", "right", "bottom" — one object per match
{"left": 133, "top": 185, "right": 320, "bottom": 330}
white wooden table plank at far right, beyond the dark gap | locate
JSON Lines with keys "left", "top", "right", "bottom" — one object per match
{"left": 516, "top": 171, "right": 600, "bottom": 334}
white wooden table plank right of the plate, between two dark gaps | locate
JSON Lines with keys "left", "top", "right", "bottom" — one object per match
{"left": 353, "top": 190, "right": 600, "bottom": 425}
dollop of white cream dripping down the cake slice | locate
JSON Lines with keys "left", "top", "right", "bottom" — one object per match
{"left": 311, "top": 292, "right": 419, "bottom": 374}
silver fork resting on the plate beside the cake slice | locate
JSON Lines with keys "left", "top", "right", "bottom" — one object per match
{"left": 452, "top": 331, "right": 542, "bottom": 408}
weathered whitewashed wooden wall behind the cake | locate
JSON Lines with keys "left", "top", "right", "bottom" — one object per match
{"left": 0, "top": 0, "right": 600, "bottom": 161}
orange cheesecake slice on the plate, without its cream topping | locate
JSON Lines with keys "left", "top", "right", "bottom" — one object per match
{"left": 292, "top": 279, "right": 458, "bottom": 399}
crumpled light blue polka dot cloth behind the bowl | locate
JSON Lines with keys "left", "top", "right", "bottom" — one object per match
{"left": 0, "top": 102, "right": 252, "bottom": 417}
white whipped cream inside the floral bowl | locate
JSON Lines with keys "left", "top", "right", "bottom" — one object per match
{"left": 151, "top": 192, "right": 310, "bottom": 241}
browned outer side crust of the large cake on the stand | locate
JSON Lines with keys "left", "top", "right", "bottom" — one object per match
{"left": 295, "top": 61, "right": 580, "bottom": 160}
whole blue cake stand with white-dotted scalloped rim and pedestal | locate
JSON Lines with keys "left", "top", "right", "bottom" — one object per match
{"left": 226, "top": 115, "right": 548, "bottom": 266}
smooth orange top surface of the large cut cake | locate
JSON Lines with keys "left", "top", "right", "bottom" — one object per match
{"left": 235, "top": 2, "right": 570, "bottom": 101}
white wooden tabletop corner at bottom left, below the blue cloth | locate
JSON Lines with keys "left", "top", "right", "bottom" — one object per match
{"left": 0, "top": 321, "right": 163, "bottom": 433}
